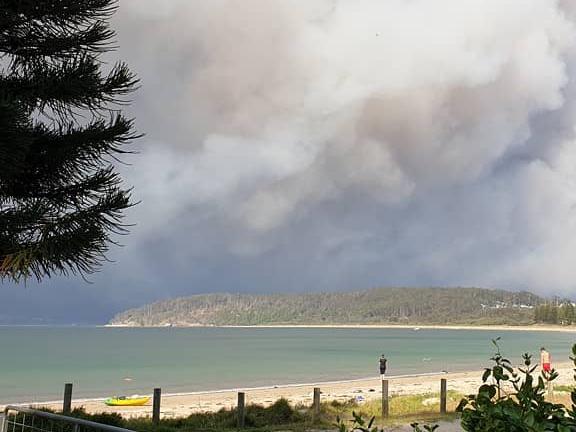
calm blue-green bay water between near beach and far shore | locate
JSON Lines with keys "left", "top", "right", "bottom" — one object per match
{"left": 0, "top": 327, "right": 576, "bottom": 404}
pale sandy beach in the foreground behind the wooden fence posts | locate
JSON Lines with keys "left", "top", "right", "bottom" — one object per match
{"left": 7, "top": 363, "right": 573, "bottom": 418}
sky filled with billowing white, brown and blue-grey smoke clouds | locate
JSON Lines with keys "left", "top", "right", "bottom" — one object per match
{"left": 0, "top": 0, "right": 576, "bottom": 324}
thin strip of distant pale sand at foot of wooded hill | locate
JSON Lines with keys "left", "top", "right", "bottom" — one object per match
{"left": 102, "top": 324, "right": 576, "bottom": 333}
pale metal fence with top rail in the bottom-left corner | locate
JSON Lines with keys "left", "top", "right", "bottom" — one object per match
{"left": 0, "top": 406, "right": 133, "bottom": 432}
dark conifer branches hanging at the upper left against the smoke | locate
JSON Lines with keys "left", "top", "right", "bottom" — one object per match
{"left": 0, "top": 0, "right": 138, "bottom": 281}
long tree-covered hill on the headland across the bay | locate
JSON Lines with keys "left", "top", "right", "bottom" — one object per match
{"left": 110, "top": 288, "right": 544, "bottom": 326}
